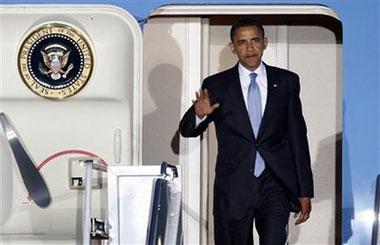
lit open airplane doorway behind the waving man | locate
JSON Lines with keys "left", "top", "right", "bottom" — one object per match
{"left": 142, "top": 5, "right": 343, "bottom": 244}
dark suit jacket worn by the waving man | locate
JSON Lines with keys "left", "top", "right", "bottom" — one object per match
{"left": 179, "top": 65, "right": 313, "bottom": 219}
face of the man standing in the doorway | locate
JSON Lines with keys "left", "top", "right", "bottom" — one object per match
{"left": 230, "top": 26, "right": 268, "bottom": 71}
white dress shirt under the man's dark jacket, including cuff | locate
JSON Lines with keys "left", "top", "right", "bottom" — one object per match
{"left": 195, "top": 62, "right": 268, "bottom": 127}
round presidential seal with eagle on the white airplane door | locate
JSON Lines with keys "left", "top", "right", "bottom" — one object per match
{"left": 18, "top": 22, "right": 94, "bottom": 99}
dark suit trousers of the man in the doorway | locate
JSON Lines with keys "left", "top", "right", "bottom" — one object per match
{"left": 214, "top": 170, "right": 290, "bottom": 245}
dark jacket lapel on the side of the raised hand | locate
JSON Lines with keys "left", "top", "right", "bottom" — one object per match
{"left": 227, "top": 65, "right": 254, "bottom": 141}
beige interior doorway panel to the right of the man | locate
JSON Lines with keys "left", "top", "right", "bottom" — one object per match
{"left": 288, "top": 26, "right": 343, "bottom": 244}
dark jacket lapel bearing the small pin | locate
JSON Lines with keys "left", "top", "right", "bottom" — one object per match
{"left": 258, "top": 64, "right": 278, "bottom": 138}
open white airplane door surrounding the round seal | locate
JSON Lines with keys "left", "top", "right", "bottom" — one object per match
{"left": 0, "top": 4, "right": 142, "bottom": 243}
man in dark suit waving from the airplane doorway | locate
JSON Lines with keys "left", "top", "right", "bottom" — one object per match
{"left": 180, "top": 18, "right": 313, "bottom": 245}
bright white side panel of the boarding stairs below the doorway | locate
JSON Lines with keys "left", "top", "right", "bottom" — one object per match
{"left": 108, "top": 166, "right": 160, "bottom": 244}
